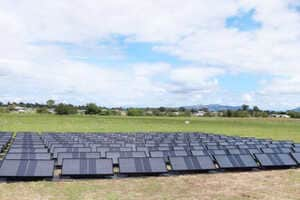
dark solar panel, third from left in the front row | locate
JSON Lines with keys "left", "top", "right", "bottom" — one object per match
{"left": 119, "top": 158, "right": 167, "bottom": 174}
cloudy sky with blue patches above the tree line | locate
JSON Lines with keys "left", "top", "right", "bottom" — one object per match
{"left": 0, "top": 0, "right": 300, "bottom": 110}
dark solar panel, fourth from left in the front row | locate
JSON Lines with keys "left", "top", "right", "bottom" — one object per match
{"left": 169, "top": 156, "right": 216, "bottom": 172}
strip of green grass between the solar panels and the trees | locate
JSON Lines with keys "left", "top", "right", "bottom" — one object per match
{"left": 0, "top": 114, "right": 300, "bottom": 142}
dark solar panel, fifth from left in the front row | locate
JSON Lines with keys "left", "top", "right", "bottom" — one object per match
{"left": 214, "top": 154, "right": 258, "bottom": 169}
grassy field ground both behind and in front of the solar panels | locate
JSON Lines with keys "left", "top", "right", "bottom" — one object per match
{"left": 0, "top": 114, "right": 300, "bottom": 200}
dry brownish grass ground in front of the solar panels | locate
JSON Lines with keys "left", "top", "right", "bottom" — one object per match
{"left": 0, "top": 169, "right": 300, "bottom": 200}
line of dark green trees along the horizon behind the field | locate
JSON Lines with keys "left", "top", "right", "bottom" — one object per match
{"left": 0, "top": 99, "right": 300, "bottom": 118}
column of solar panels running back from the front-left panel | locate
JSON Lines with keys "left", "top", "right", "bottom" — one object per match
{"left": 0, "top": 133, "right": 54, "bottom": 179}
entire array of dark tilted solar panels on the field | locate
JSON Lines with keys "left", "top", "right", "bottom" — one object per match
{"left": 0, "top": 132, "right": 300, "bottom": 179}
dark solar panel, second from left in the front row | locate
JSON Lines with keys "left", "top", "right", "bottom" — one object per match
{"left": 62, "top": 159, "right": 113, "bottom": 176}
